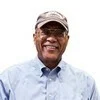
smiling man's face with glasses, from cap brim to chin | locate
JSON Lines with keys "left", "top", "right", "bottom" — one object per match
{"left": 34, "top": 22, "right": 69, "bottom": 61}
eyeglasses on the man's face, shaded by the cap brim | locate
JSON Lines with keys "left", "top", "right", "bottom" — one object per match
{"left": 38, "top": 28, "right": 68, "bottom": 38}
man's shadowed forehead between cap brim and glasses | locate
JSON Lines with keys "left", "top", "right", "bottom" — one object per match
{"left": 41, "top": 21, "right": 65, "bottom": 30}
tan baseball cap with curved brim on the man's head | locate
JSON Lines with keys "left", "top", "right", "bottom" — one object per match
{"left": 35, "top": 11, "right": 69, "bottom": 32}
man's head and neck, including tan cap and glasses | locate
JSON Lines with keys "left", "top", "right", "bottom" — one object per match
{"left": 33, "top": 11, "right": 69, "bottom": 69}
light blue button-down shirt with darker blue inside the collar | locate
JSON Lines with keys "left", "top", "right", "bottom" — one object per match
{"left": 0, "top": 58, "right": 100, "bottom": 100}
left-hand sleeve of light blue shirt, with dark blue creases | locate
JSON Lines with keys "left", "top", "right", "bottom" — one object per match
{"left": 0, "top": 71, "right": 15, "bottom": 100}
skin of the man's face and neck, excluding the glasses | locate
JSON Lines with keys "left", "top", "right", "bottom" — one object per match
{"left": 33, "top": 22, "right": 69, "bottom": 69}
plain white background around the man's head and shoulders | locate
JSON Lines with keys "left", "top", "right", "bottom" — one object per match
{"left": 0, "top": 0, "right": 100, "bottom": 90}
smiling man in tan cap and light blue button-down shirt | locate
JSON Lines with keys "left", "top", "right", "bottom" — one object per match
{"left": 0, "top": 11, "right": 100, "bottom": 100}
